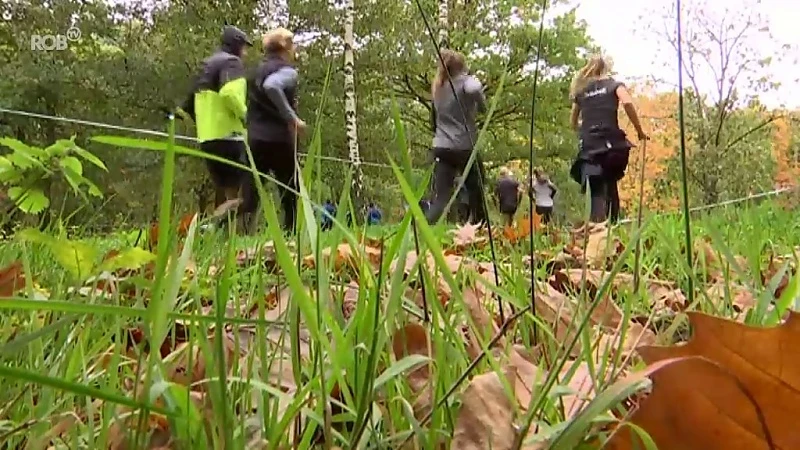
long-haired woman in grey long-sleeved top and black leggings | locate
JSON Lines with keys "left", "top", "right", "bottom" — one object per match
{"left": 426, "top": 49, "right": 487, "bottom": 223}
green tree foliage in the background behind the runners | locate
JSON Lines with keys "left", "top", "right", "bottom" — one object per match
{"left": 0, "top": 0, "right": 591, "bottom": 225}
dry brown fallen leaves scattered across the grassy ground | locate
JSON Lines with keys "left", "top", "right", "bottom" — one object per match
{"left": 0, "top": 216, "right": 800, "bottom": 450}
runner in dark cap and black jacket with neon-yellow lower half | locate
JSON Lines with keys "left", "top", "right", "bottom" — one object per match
{"left": 178, "top": 26, "right": 253, "bottom": 211}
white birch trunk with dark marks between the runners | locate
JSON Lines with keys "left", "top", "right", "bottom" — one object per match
{"left": 344, "top": 0, "right": 364, "bottom": 199}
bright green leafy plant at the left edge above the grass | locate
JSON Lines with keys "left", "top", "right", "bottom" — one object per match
{"left": 0, "top": 136, "right": 108, "bottom": 214}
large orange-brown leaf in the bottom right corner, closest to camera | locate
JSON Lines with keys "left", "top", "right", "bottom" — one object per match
{"left": 606, "top": 312, "right": 800, "bottom": 450}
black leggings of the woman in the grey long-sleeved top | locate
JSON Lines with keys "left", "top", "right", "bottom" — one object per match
{"left": 426, "top": 147, "right": 486, "bottom": 223}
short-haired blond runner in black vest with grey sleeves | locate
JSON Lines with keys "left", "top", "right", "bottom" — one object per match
{"left": 242, "top": 28, "right": 306, "bottom": 231}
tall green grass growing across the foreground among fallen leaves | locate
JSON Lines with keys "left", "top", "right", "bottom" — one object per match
{"left": 0, "top": 64, "right": 798, "bottom": 449}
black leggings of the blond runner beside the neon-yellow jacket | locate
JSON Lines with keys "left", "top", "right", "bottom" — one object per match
{"left": 242, "top": 140, "right": 299, "bottom": 231}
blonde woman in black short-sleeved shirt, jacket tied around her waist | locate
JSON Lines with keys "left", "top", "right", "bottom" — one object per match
{"left": 570, "top": 56, "right": 648, "bottom": 222}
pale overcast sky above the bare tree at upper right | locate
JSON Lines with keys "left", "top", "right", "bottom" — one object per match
{"left": 574, "top": 0, "right": 800, "bottom": 108}
